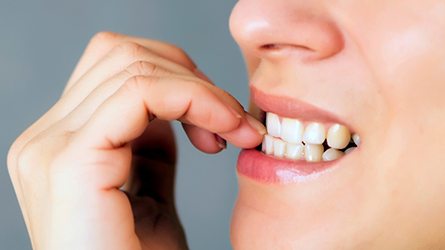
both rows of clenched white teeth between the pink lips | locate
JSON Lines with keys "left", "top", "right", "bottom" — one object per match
{"left": 262, "top": 112, "right": 360, "bottom": 162}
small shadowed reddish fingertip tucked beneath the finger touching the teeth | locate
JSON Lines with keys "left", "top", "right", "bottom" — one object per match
{"left": 182, "top": 123, "right": 226, "bottom": 154}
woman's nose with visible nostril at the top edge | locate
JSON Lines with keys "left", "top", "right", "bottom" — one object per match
{"left": 230, "top": 0, "right": 344, "bottom": 61}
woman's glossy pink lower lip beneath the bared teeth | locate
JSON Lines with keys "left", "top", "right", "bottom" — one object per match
{"left": 237, "top": 149, "right": 340, "bottom": 184}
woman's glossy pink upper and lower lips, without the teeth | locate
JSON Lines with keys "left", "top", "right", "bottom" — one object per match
{"left": 237, "top": 86, "right": 345, "bottom": 184}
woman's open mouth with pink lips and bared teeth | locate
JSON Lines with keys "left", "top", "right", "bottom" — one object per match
{"left": 237, "top": 86, "right": 361, "bottom": 184}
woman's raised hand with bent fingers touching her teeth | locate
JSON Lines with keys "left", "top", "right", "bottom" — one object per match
{"left": 8, "top": 33, "right": 265, "bottom": 250}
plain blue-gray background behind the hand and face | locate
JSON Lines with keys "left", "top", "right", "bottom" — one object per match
{"left": 0, "top": 0, "right": 247, "bottom": 250}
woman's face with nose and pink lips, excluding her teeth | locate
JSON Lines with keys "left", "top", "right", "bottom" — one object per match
{"left": 230, "top": 0, "right": 445, "bottom": 249}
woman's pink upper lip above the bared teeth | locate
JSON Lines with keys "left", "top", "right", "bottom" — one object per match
{"left": 250, "top": 85, "right": 351, "bottom": 128}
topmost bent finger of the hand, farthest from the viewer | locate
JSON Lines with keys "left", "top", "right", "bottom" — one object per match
{"left": 64, "top": 32, "right": 196, "bottom": 92}
